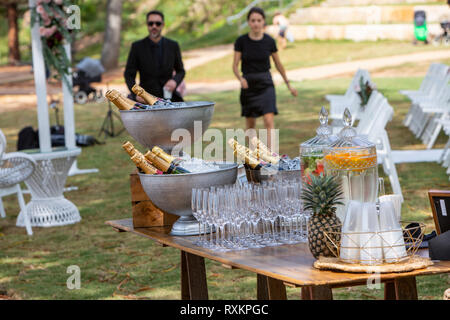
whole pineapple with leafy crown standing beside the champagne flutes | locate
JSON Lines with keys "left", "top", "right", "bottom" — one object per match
{"left": 302, "top": 174, "right": 343, "bottom": 259}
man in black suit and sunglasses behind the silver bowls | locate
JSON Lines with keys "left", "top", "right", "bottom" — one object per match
{"left": 124, "top": 10, "right": 185, "bottom": 102}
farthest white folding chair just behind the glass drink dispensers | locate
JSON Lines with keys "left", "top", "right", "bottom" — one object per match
{"left": 325, "top": 69, "right": 370, "bottom": 126}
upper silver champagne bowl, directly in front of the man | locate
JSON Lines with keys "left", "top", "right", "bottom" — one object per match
{"left": 120, "top": 101, "right": 214, "bottom": 153}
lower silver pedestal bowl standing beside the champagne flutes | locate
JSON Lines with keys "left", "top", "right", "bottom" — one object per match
{"left": 139, "top": 163, "right": 238, "bottom": 235}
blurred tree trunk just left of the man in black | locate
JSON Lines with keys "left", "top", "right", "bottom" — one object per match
{"left": 101, "top": 0, "right": 122, "bottom": 70}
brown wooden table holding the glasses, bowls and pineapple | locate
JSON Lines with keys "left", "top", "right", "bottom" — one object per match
{"left": 106, "top": 219, "right": 450, "bottom": 300}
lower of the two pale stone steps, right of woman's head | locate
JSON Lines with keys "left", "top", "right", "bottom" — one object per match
{"left": 267, "top": 23, "right": 442, "bottom": 41}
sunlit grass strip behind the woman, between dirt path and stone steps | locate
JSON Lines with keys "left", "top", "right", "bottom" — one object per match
{"left": 186, "top": 40, "right": 443, "bottom": 81}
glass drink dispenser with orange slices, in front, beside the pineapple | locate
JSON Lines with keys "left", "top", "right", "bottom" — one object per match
{"left": 324, "top": 109, "right": 378, "bottom": 221}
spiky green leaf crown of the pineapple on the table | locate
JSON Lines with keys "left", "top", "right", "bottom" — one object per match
{"left": 302, "top": 174, "right": 344, "bottom": 215}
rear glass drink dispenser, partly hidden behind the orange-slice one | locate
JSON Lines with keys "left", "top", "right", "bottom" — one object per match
{"left": 300, "top": 107, "right": 338, "bottom": 182}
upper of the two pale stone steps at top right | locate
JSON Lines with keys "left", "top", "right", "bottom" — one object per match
{"left": 289, "top": 5, "right": 450, "bottom": 25}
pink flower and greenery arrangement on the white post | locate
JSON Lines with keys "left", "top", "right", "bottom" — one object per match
{"left": 31, "top": 0, "right": 72, "bottom": 90}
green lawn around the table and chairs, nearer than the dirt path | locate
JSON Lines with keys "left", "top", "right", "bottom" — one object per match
{"left": 0, "top": 78, "right": 450, "bottom": 299}
